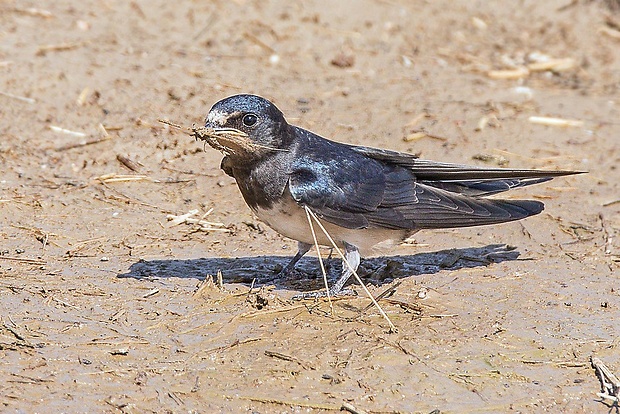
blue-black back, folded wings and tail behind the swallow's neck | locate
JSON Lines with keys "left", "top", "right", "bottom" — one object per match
{"left": 289, "top": 131, "right": 580, "bottom": 230}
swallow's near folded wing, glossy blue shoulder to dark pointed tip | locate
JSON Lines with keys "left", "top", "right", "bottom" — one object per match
{"left": 289, "top": 147, "right": 544, "bottom": 230}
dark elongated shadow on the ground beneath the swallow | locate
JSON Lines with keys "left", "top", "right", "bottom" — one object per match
{"left": 118, "top": 244, "right": 520, "bottom": 291}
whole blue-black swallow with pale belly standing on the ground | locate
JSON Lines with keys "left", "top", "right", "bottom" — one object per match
{"left": 195, "top": 95, "right": 581, "bottom": 295}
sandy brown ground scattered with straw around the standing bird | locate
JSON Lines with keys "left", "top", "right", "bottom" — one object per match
{"left": 0, "top": 0, "right": 620, "bottom": 413}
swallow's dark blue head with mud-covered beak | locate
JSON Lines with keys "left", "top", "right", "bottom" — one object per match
{"left": 200, "top": 95, "right": 289, "bottom": 161}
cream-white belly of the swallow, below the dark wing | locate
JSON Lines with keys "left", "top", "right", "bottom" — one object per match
{"left": 252, "top": 199, "right": 415, "bottom": 255}
